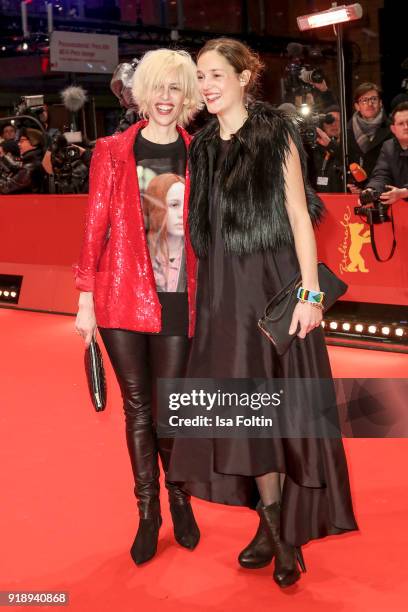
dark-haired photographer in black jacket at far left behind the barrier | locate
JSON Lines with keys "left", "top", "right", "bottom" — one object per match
{"left": 0, "top": 128, "right": 45, "bottom": 195}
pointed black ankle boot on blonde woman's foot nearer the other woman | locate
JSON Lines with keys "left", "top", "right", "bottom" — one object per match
{"left": 166, "top": 482, "right": 200, "bottom": 550}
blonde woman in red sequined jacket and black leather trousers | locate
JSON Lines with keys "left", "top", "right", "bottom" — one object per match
{"left": 76, "top": 49, "right": 200, "bottom": 565}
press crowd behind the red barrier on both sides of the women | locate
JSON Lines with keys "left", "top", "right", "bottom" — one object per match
{"left": 0, "top": 75, "right": 408, "bottom": 198}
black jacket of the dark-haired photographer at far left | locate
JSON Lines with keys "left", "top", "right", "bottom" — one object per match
{"left": 0, "top": 148, "right": 45, "bottom": 195}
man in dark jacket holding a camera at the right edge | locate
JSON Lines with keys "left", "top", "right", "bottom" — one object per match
{"left": 365, "top": 102, "right": 408, "bottom": 204}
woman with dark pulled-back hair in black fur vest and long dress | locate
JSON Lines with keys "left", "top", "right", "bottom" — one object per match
{"left": 169, "top": 39, "right": 357, "bottom": 587}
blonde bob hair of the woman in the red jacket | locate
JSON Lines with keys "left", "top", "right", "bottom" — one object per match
{"left": 132, "top": 49, "right": 202, "bottom": 125}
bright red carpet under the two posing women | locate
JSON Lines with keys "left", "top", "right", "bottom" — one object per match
{"left": 0, "top": 309, "right": 408, "bottom": 612}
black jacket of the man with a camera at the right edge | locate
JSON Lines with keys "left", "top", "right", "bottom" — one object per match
{"left": 367, "top": 138, "right": 408, "bottom": 193}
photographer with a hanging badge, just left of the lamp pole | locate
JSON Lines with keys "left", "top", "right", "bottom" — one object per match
{"left": 306, "top": 105, "right": 342, "bottom": 193}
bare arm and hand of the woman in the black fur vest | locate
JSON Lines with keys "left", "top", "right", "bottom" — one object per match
{"left": 284, "top": 140, "right": 322, "bottom": 338}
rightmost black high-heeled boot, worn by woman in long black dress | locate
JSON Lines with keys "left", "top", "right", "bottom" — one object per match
{"left": 259, "top": 502, "right": 306, "bottom": 588}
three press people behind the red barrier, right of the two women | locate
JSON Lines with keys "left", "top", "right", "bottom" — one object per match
{"left": 307, "top": 82, "right": 408, "bottom": 198}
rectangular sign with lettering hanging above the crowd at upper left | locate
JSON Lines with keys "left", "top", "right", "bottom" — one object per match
{"left": 50, "top": 30, "right": 119, "bottom": 74}
